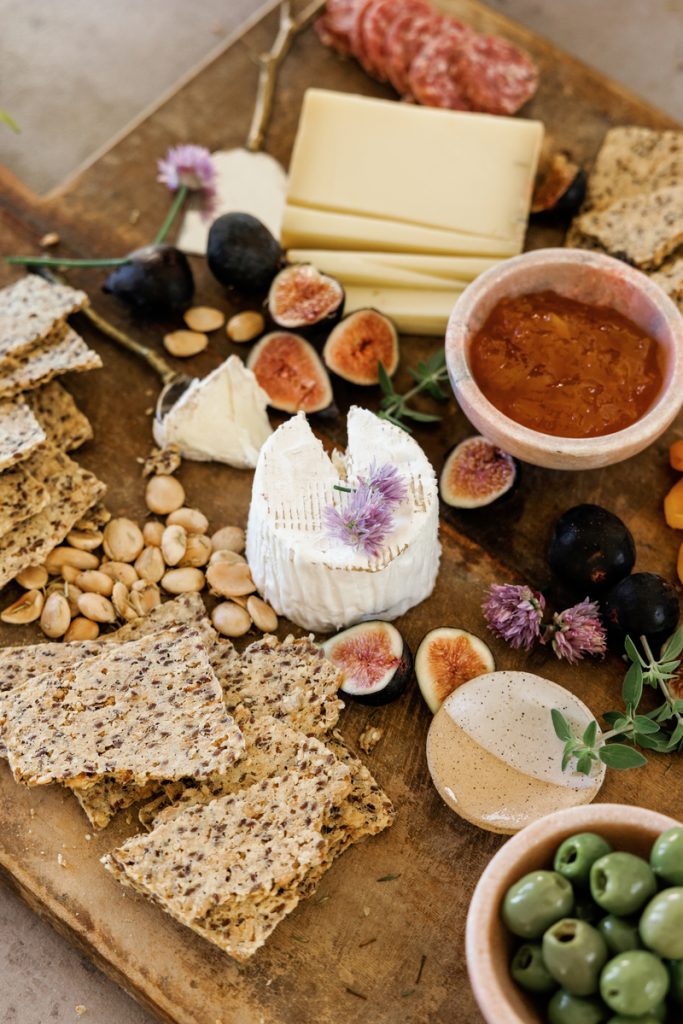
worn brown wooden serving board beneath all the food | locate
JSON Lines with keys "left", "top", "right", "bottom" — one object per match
{"left": 0, "top": 0, "right": 683, "bottom": 1024}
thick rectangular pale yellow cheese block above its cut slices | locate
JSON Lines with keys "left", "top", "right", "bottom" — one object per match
{"left": 287, "top": 89, "right": 544, "bottom": 241}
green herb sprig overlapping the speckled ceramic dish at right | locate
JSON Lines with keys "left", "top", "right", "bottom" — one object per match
{"left": 551, "top": 626, "right": 683, "bottom": 775}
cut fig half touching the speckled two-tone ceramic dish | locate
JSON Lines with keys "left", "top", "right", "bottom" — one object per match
{"left": 415, "top": 626, "right": 496, "bottom": 715}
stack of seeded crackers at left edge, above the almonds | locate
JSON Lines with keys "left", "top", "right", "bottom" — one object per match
{"left": 0, "top": 274, "right": 104, "bottom": 587}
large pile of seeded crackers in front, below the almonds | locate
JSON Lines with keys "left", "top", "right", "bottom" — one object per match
{"left": 0, "top": 593, "right": 394, "bottom": 961}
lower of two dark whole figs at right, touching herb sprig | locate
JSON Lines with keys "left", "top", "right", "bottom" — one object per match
{"left": 602, "top": 572, "right": 681, "bottom": 656}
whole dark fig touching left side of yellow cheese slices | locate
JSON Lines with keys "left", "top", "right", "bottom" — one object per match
{"left": 206, "top": 213, "right": 283, "bottom": 294}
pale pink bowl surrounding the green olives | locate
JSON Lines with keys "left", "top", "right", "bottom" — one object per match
{"left": 466, "top": 804, "right": 680, "bottom": 1024}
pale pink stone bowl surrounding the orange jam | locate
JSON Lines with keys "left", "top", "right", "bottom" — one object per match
{"left": 445, "top": 249, "right": 683, "bottom": 469}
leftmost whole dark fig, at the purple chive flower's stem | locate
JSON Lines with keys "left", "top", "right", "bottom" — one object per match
{"left": 102, "top": 246, "right": 195, "bottom": 313}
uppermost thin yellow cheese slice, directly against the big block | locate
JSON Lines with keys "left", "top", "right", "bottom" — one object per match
{"left": 281, "top": 204, "right": 523, "bottom": 257}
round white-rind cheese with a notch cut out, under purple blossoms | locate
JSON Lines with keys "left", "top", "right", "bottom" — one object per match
{"left": 247, "top": 407, "right": 440, "bottom": 633}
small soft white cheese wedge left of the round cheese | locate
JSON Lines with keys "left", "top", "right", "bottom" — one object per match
{"left": 154, "top": 355, "right": 272, "bottom": 469}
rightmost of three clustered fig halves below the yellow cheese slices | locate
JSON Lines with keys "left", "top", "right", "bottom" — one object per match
{"left": 323, "top": 309, "right": 398, "bottom": 384}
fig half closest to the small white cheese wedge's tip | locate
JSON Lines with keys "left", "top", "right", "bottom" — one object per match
{"left": 247, "top": 331, "right": 333, "bottom": 413}
